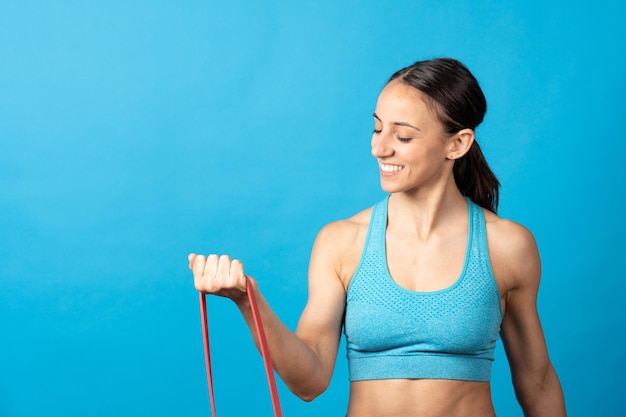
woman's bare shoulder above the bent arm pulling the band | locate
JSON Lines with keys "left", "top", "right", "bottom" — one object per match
{"left": 311, "top": 208, "right": 372, "bottom": 288}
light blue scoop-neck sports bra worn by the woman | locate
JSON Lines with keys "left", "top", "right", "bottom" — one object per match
{"left": 344, "top": 197, "right": 502, "bottom": 381}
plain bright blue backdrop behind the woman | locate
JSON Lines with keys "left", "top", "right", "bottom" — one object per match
{"left": 0, "top": 0, "right": 626, "bottom": 417}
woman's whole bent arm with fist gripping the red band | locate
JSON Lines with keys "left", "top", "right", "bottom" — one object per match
{"left": 189, "top": 224, "right": 345, "bottom": 401}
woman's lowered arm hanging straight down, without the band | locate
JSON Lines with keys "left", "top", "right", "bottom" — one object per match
{"left": 488, "top": 216, "right": 566, "bottom": 417}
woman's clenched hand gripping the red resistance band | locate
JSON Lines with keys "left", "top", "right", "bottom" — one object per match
{"left": 189, "top": 253, "right": 246, "bottom": 301}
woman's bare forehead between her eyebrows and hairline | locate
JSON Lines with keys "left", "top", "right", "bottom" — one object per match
{"left": 376, "top": 80, "right": 439, "bottom": 122}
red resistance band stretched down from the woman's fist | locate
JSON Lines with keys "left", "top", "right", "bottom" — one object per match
{"left": 200, "top": 277, "right": 283, "bottom": 417}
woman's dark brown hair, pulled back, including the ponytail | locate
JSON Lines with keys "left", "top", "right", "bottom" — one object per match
{"left": 389, "top": 58, "right": 500, "bottom": 213}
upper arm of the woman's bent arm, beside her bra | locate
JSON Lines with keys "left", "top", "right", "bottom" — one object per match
{"left": 296, "top": 223, "right": 346, "bottom": 381}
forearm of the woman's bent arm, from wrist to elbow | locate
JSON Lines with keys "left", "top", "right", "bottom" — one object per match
{"left": 236, "top": 283, "right": 332, "bottom": 401}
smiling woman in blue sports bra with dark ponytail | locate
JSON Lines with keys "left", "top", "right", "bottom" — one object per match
{"left": 189, "top": 58, "right": 565, "bottom": 417}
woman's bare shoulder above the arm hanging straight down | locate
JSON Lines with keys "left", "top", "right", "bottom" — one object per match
{"left": 484, "top": 210, "right": 541, "bottom": 292}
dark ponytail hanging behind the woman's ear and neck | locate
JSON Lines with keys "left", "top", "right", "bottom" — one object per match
{"left": 453, "top": 141, "right": 500, "bottom": 213}
